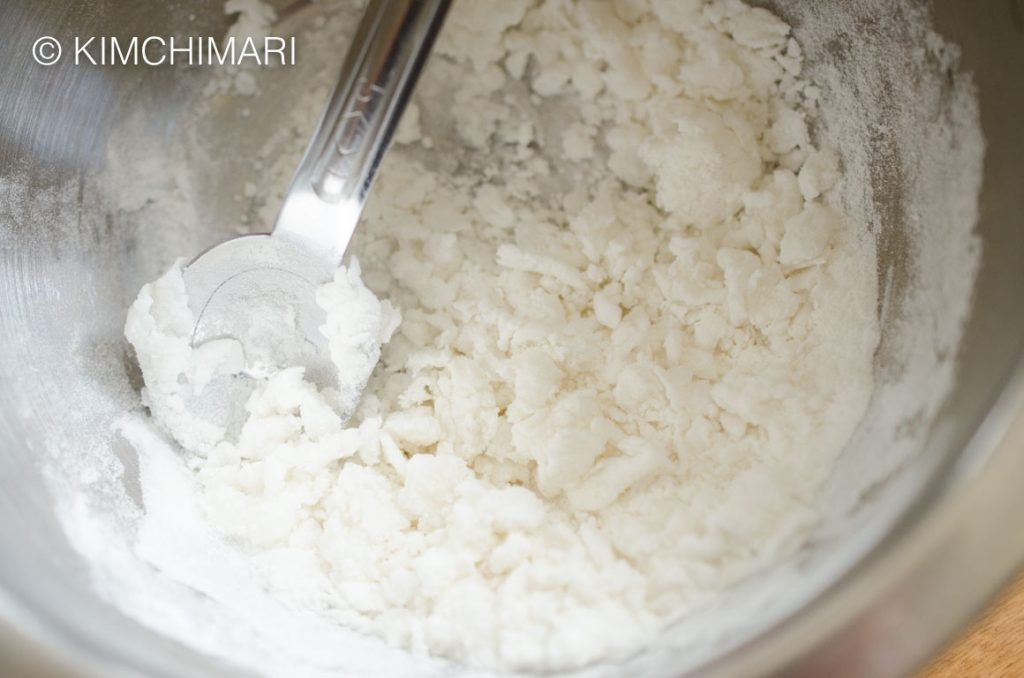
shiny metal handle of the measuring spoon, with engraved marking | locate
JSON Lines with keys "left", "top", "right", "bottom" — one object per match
{"left": 273, "top": 0, "right": 451, "bottom": 264}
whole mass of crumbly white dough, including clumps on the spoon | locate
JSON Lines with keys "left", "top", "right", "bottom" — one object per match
{"left": 128, "top": 0, "right": 879, "bottom": 670}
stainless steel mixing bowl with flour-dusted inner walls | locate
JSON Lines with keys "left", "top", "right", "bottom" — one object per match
{"left": 0, "top": 0, "right": 1024, "bottom": 678}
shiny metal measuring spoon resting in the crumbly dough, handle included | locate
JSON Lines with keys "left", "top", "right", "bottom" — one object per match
{"left": 183, "top": 0, "right": 451, "bottom": 431}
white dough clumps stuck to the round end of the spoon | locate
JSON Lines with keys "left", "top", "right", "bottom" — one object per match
{"left": 125, "top": 257, "right": 401, "bottom": 455}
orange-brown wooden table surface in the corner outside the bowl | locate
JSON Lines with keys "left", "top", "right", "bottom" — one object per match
{"left": 918, "top": 575, "right": 1024, "bottom": 678}
